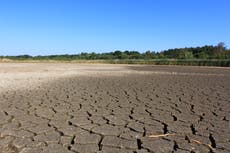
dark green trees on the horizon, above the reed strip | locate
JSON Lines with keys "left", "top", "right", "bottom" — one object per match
{"left": 0, "top": 42, "right": 230, "bottom": 61}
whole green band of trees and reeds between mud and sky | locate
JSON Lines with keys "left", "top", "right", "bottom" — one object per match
{"left": 0, "top": 42, "right": 230, "bottom": 66}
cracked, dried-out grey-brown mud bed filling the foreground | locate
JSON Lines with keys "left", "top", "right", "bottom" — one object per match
{"left": 0, "top": 63, "right": 230, "bottom": 153}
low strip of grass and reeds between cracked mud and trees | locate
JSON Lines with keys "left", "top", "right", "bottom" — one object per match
{"left": 0, "top": 58, "right": 230, "bottom": 67}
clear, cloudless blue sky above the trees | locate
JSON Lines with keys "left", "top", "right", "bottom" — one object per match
{"left": 0, "top": 0, "right": 230, "bottom": 55}
